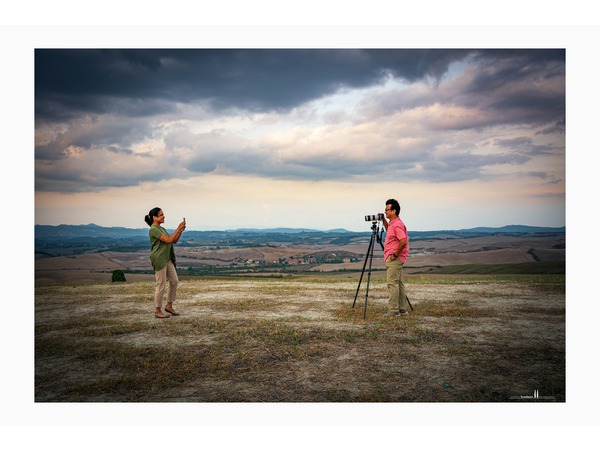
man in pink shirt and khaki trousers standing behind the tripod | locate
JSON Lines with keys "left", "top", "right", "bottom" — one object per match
{"left": 383, "top": 199, "right": 408, "bottom": 316}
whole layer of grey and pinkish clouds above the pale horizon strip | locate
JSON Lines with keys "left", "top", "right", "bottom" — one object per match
{"left": 35, "top": 49, "right": 565, "bottom": 192}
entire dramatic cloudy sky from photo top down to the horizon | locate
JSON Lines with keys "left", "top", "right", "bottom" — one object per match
{"left": 35, "top": 49, "right": 565, "bottom": 231}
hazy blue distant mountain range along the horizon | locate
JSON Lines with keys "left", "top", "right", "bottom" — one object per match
{"left": 35, "top": 224, "right": 566, "bottom": 239}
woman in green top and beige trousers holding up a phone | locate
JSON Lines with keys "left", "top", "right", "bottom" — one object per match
{"left": 144, "top": 208, "right": 185, "bottom": 319}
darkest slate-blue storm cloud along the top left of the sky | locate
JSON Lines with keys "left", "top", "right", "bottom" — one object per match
{"left": 35, "top": 49, "right": 478, "bottom": 120}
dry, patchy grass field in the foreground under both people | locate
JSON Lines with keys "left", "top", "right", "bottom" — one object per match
{"left": 35, "top": 272, "right": 566, "bottom": 402}
